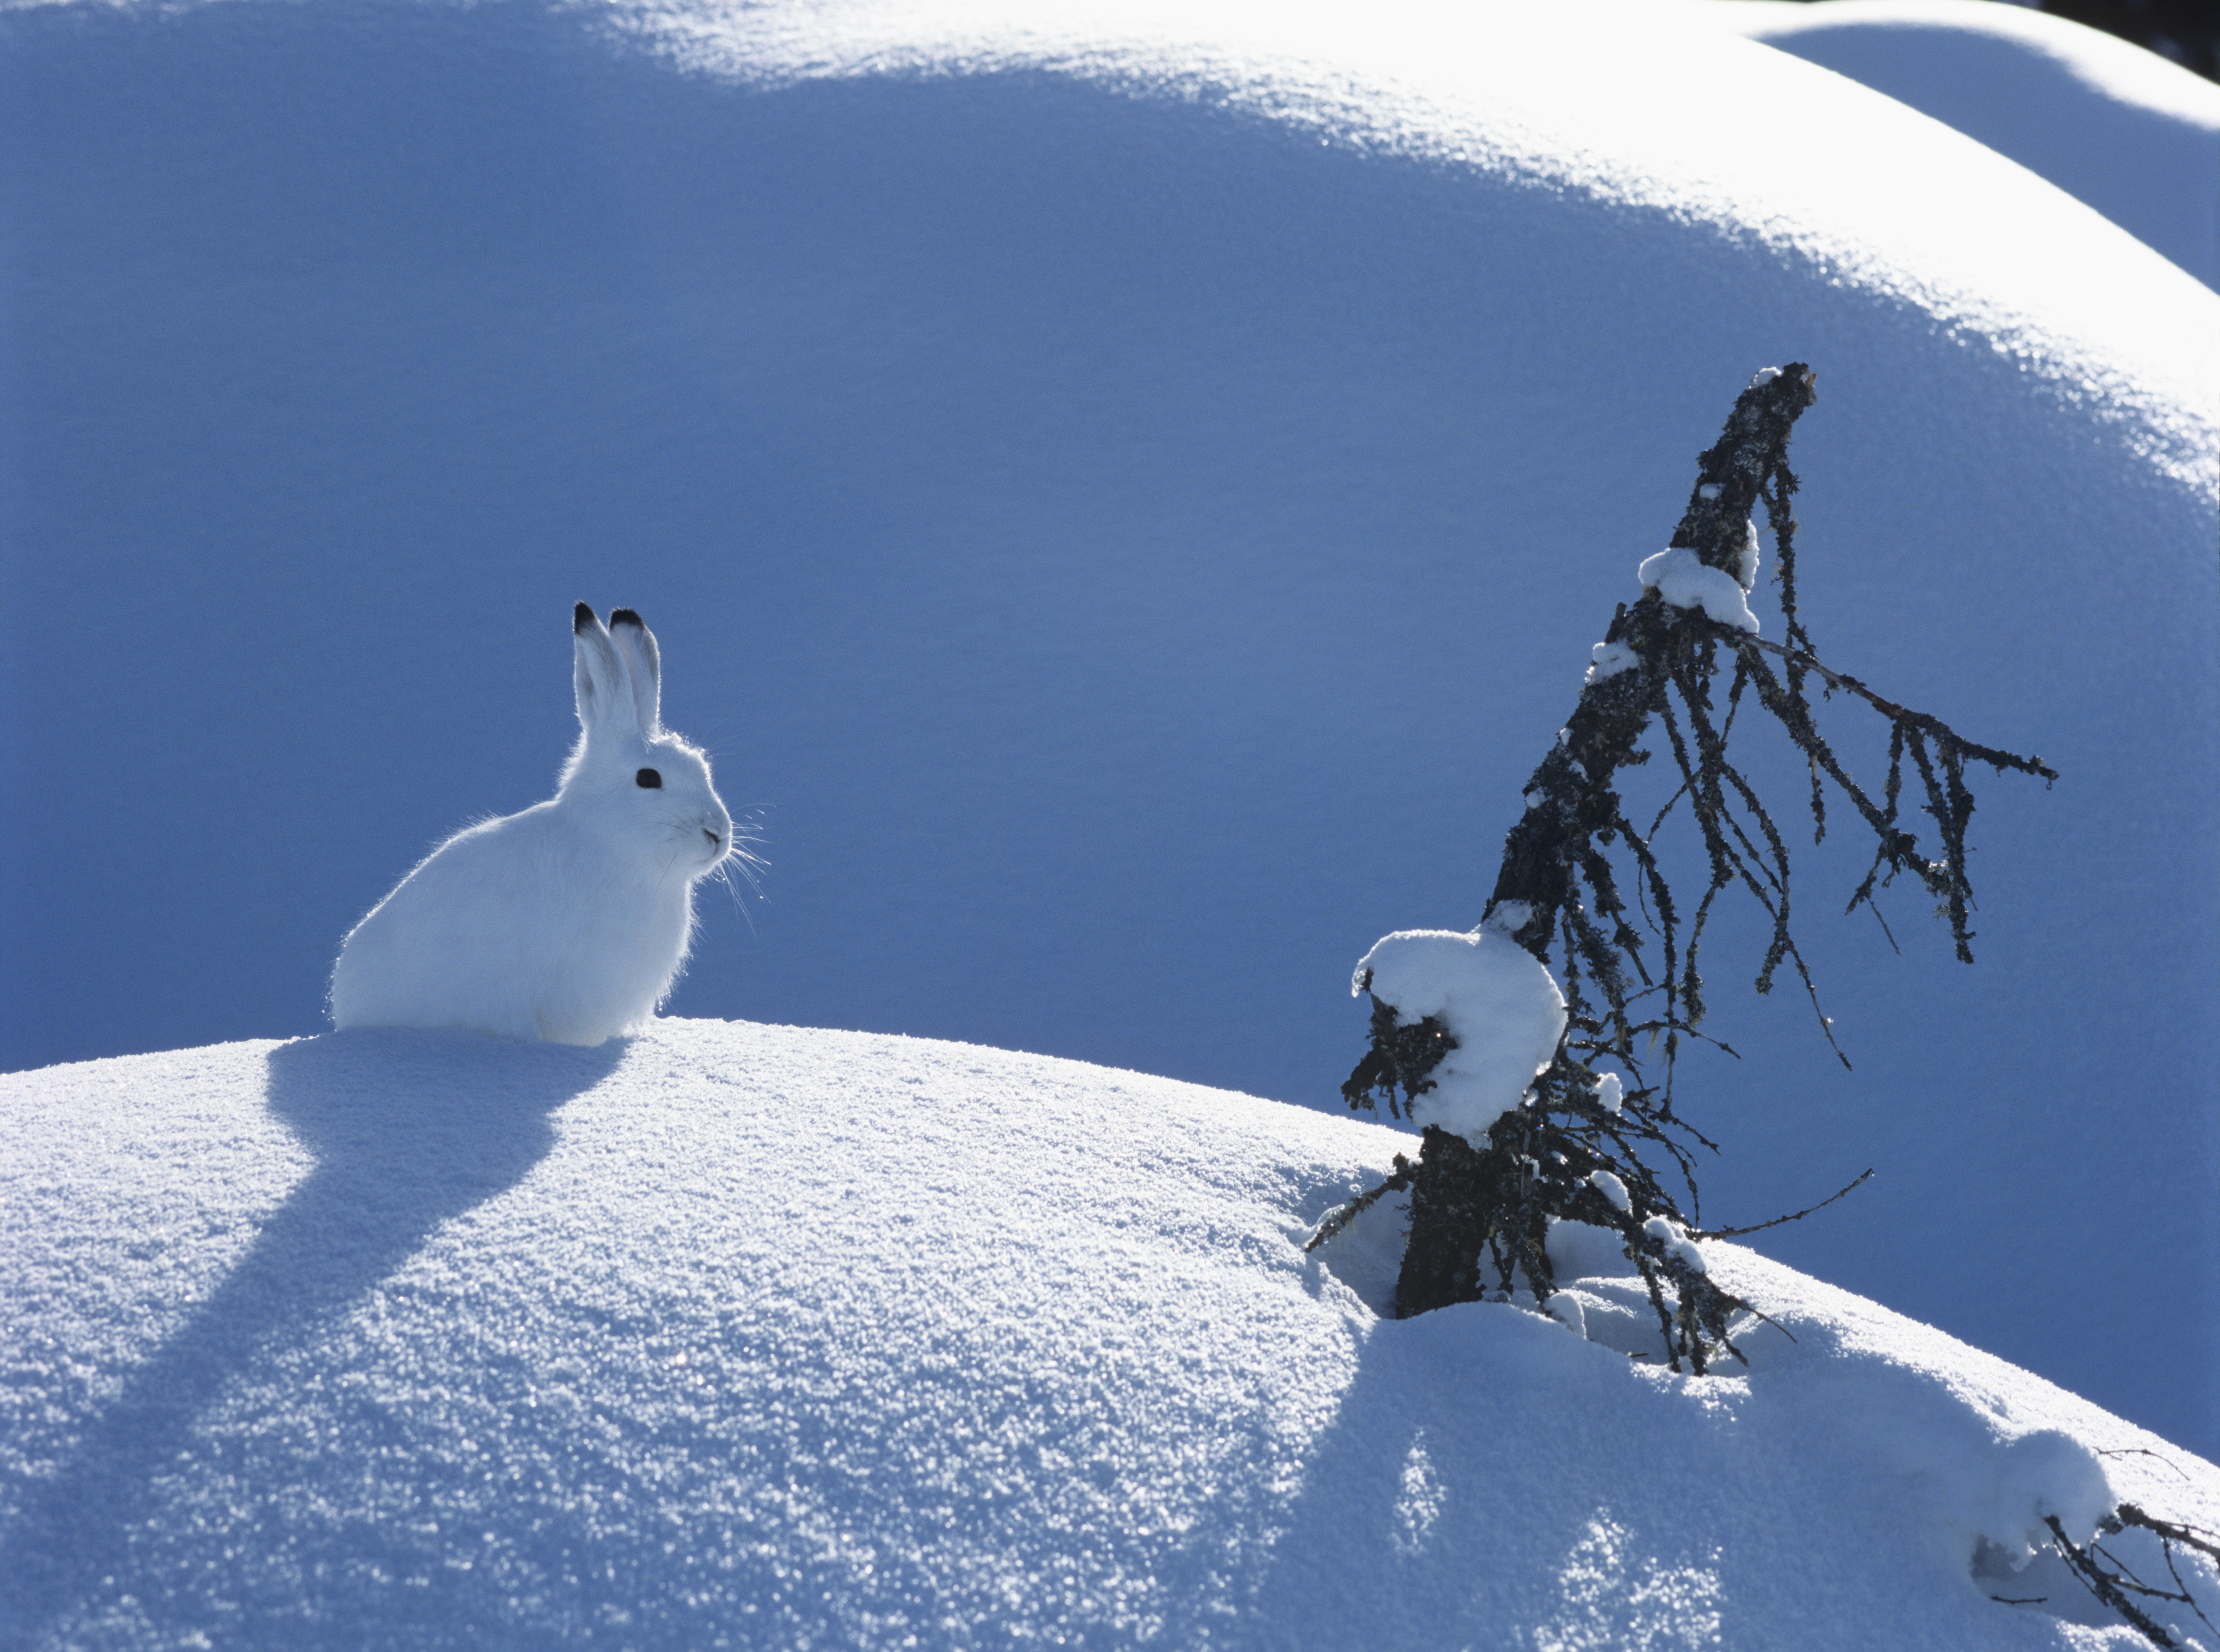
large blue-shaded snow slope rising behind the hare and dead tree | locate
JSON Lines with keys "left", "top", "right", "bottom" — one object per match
{"left": 0, "top": 0, "right": 2220, "bottom": 1455}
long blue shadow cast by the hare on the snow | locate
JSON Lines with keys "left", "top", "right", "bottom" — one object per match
{"left": 0, "top": 1033, "right": 624, "bottom": 1645}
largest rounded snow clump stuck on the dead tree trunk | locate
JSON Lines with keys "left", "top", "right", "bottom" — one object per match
{"left": 1350, "top": 928, "right": 1565, "bottom": 1148}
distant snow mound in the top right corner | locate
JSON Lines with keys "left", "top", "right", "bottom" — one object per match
{"left": 1674, "top": 0, "right": 2220, "bottom": 286}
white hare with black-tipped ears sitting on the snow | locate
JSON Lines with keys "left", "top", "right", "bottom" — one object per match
{"left": 331, "top": 602, "right": 733, "bottom": 1043}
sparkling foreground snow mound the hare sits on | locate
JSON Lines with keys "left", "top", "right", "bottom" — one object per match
{"left": 0, "top": 1021, "right": 2220, "bottom": 1652}
